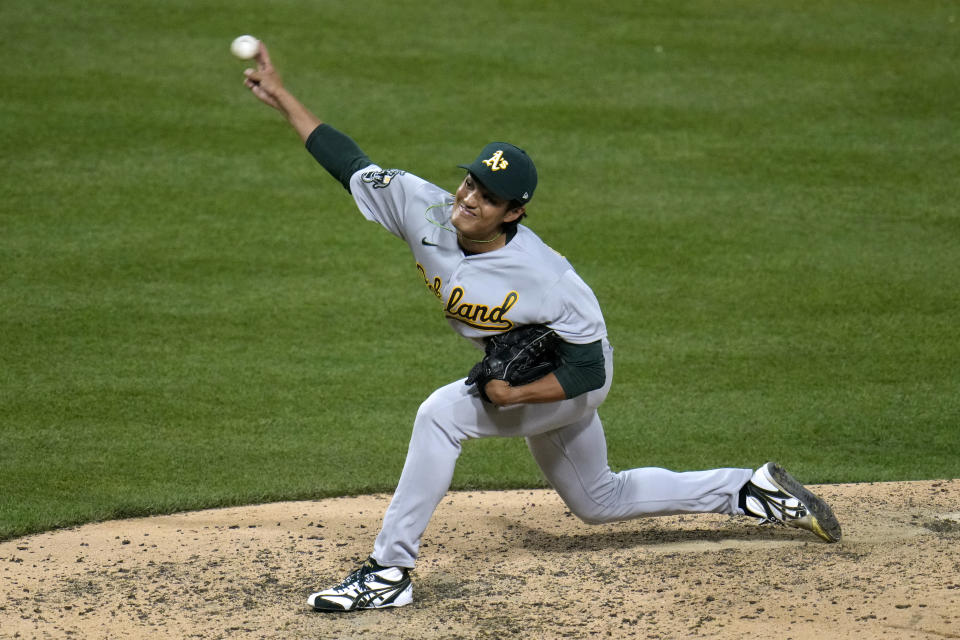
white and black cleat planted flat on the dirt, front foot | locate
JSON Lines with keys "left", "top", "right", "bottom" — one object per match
{"left": 307, "top": 558, "right": 413, "bottom": 612}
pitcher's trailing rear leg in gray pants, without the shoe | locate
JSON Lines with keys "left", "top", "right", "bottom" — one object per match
{"left": 527, "top": 412, "right": 753, "bottom": 523}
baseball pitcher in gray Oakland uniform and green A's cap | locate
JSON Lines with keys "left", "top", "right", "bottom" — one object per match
{"left": 244, "top": 43, "right": 841, "bottom": 612}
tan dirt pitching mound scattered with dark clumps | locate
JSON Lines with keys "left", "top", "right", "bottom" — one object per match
{"left": 0, "top": 480, "right": 960, "bottom": 640}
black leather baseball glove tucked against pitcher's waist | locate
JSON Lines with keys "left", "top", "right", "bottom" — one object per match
{"left": 464, "top": 324, "right": 560, "bottom": 402}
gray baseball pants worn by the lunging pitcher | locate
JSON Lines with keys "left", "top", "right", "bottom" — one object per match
{"left": 372, "top": 341, "right": 753, "bottom": 568}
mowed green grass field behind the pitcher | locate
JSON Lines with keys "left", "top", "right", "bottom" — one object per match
{"left": 0, "top": 0, "right": 960, "bottom": 539}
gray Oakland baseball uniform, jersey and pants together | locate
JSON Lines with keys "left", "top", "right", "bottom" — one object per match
{"left": 349, "top": 165, "right": 753, "bottom": 568}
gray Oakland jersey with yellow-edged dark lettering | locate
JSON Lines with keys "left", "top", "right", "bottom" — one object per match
{"left": 350, "top": 165, "right": 607, "bottom": 344}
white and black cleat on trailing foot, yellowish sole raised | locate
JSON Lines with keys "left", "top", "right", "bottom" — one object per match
{"left": 742, "top": 462, "right": 842, "bottom": 542}
